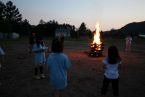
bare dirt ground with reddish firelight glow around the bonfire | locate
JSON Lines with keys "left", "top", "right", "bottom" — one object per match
{"left": 0, "top": 39, "right": 145, "bottom": 97}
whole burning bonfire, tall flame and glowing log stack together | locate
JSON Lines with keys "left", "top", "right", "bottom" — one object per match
{"left": 89, "top": 23, "right": 104, "bottom": 56}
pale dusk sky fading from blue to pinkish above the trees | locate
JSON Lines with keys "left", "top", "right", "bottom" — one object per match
{"left": 2, "top": 0, "right": 145, "bottom": 31}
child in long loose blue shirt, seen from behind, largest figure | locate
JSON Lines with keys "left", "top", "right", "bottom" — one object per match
{"left": 47, "top": 38, "right": 71, "bottom": 97}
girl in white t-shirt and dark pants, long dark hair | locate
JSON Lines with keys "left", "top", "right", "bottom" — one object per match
{"left": 102, "top": 45, "right": 121, "bottom": 96}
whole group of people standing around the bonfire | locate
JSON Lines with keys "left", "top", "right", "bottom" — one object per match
{"left": 0, "top": 33, "right": 132, "bottom": 97}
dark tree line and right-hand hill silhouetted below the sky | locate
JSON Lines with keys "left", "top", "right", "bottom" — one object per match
{"left": 0, "top": 0, "right": 145, "bottom": 38}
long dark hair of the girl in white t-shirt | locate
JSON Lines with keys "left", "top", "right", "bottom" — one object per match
{"left": 108, "top": 45, "right": 121, "bottom": 64}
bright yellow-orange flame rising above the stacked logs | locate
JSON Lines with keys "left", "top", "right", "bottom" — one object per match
{"left": 93, "top": 23, "right": 102, "bottom": 44}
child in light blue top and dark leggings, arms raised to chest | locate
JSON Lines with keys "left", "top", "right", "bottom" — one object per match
{"left": 32, "top": 37, "right": 47, "bottom": 79}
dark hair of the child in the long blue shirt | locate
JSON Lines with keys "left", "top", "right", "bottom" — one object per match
{"left": 51, "top": 38, "right": 63, "bottom": 53}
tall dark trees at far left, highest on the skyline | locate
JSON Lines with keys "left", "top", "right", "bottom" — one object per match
{"left": 0, "top": 1, "right": 32, "bottom": 34}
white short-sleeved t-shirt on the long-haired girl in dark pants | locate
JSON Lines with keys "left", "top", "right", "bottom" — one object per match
{"left": 103, "top": 58, "right": 121, "bottom": 79}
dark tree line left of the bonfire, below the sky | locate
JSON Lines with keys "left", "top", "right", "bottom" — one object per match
{"left": 0, "top": 1, "right": 91, "bottom": 38}
